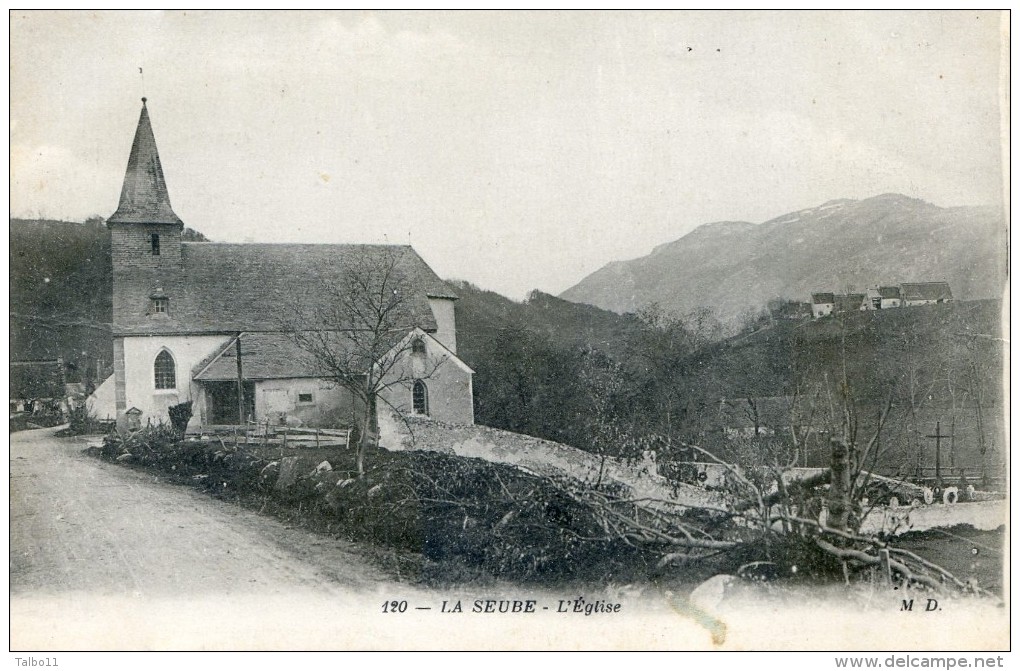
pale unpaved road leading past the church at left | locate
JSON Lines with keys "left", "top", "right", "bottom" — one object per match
{"left": 10, "top": 429, "right": 385, "bottom": 597}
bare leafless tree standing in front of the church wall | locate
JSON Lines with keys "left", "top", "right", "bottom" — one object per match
{"left": 285, "top": 250, "right": 445, "bottom": 476}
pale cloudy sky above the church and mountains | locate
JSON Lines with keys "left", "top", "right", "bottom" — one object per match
{"left": 10, "top": 11, "right": 1005, "bottom": 299}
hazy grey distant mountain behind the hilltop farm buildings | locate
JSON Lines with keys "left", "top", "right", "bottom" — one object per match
{"left": 560, "top": 194, "right": 1006, "bottom": 320}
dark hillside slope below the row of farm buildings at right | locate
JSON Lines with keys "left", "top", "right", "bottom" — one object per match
{"left": 676, "top": 300, "right": 1007, "bottom": 471}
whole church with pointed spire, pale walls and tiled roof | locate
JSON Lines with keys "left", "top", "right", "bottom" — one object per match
{"left": 107, "top": 98, "right": 473, "bottom": 430}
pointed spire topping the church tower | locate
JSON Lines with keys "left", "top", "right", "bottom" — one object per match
{"left": 108, "top": 98, "right": 184, "bottom": 226}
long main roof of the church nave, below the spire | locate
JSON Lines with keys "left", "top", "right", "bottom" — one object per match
{"left": 114, "top": 243, "right": 457, "bottom": 334}
